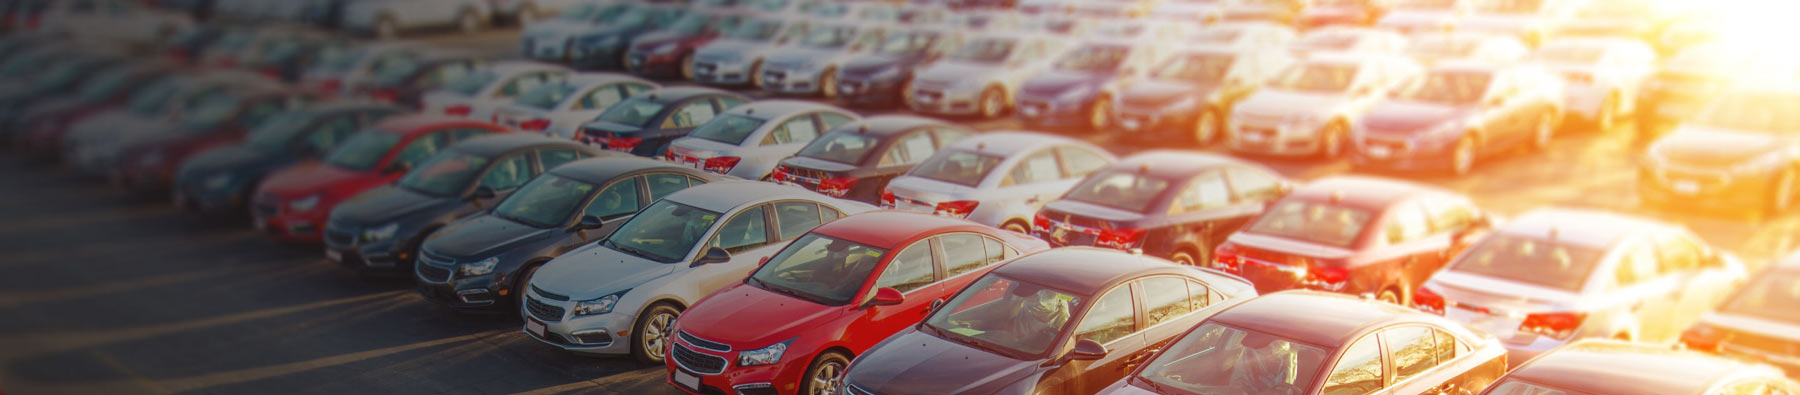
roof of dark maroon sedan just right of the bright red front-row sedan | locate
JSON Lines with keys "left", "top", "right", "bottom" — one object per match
{"left": 994, "top": 247, "right": 1195, "bottom": 296}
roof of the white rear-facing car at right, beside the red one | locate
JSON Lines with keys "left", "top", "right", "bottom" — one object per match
{"left": 1494, "top": 207, "right": 1672, "bottom": 249}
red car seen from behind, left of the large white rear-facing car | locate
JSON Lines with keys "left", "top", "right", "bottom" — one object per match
{"left": 1213, "top": 177, "right": 1490, "bottom": 305}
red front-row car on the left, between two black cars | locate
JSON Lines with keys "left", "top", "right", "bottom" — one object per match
{"left": 250, "top": 114, "right": 509, "bottom": 242}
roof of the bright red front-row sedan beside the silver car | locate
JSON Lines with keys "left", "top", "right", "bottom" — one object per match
{"left": 812, "top": 209, "right": 992, "bottom": 249}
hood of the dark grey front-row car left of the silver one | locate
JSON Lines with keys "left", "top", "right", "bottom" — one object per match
{"left": 425, "top": 215, "right": 562, "bottom": 258}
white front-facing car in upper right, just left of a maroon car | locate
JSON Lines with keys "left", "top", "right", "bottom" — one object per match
{"left": 1226, "top": 54, "right": 1424, "bottom": 159}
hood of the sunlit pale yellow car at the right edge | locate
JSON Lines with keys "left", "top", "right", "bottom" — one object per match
{"left": 1649, "top": 128, "right": 1787, "bottom": 168}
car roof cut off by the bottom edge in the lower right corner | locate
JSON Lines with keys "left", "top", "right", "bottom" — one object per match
{"left": 1507, "top": 341, "right": 1750, "bottom": 393}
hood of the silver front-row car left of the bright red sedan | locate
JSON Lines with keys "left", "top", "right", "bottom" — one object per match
{"left": 531, "top": 243, "right": 677, "bottom": 299}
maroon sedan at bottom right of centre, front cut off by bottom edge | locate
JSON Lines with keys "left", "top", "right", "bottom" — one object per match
{"left": 1102, "top": 290, "right": 1507, "bottom": 395}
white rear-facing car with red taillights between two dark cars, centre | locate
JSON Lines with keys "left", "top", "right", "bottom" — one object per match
{"left": 882, "top": 132, "right": 1118, "bottom": 233}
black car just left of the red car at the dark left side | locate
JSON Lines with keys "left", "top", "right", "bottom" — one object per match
{"left": 171, "top": 103, "right": 405, "bottom": 215}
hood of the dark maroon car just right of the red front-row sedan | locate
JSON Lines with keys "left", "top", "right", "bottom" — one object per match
{"left": 846, "top": 330, "right": 1039, "bottom": 393}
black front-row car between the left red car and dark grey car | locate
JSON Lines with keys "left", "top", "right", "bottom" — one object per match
{"left": 324, "top": 133, "right": 623, "bottom": 272}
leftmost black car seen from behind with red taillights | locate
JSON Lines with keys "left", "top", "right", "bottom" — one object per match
{"left": 574, "top": 87, "right": 751, "bottom": 157}
